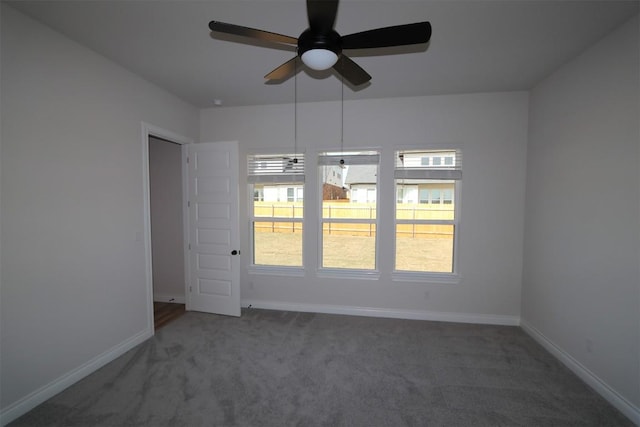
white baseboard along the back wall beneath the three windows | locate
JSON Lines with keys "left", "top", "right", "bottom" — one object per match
{"left": 241, "top": 299, "right": 520, "bottom": 326}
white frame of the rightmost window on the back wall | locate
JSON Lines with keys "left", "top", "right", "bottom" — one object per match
{"left": 391, "top": 147, "right": 462, "bottom": 283}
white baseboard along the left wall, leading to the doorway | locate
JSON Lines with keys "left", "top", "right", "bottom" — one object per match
{"left": 0, "top": 329, "right": 153, "bottom": 426}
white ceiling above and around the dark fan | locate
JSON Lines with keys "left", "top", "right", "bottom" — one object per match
{"left": 9, "top": 0, "right": 639, "bottom": 108}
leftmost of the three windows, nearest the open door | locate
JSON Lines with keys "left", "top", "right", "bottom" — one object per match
{"left": 247, "top": 154, "right": 304, "bottom": 267}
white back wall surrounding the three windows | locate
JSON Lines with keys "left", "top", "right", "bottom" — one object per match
{"left": 200, "top": 91, "right": 528, "bottom": 324}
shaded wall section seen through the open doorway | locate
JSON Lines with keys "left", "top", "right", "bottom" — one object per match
{"left": 149, "top": 137, "right": 185, "bottom": 304}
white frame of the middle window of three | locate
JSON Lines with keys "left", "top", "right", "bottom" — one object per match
{"left": 317, "top": 149, "right": 378, "bottom": 280}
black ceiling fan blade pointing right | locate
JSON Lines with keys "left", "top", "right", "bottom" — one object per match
{"left": 342, "top": 22, "right": 431, "bottom": 49}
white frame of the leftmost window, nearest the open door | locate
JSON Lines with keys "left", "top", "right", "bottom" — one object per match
{"left": 247, "top": 153, "right": 305, "bottom": 277}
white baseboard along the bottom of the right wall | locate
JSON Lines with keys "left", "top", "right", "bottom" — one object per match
{"left": 521, "top": 320, "right": 640, "bottom": 425}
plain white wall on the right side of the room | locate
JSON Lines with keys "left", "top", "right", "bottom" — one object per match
{"left": 522, "top": 18, "right": 640, "bottom": 423}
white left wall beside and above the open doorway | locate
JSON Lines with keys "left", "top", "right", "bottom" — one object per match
{"left": 0, "top": 3, "right": 198, "bottom": 422}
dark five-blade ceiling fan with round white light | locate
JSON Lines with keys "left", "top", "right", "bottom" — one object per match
{"left": 209, "top": 0, "right": 431, "bottom": 86}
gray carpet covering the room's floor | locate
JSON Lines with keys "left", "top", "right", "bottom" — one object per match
{"left": 11, "top": 309, "right": 632, "bottom": 427}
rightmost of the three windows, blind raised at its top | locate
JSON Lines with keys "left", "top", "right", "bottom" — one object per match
{"left": 394, "top": 150, "right": 462, "bottom": 274}
